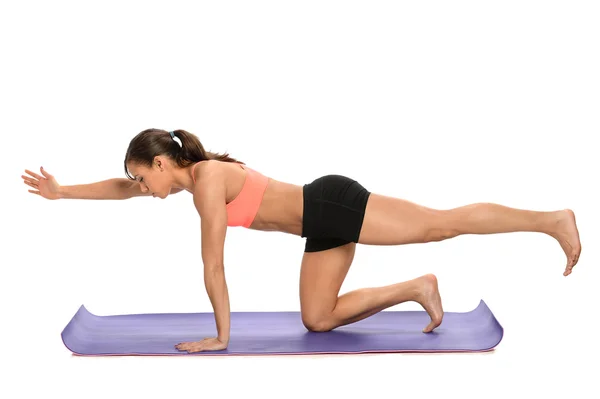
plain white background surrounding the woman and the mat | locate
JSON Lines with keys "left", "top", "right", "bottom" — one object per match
{"left": 0, "top": 0, "right": 600, "bottom": 398}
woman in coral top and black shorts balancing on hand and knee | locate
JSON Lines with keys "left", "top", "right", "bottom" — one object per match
{"left": 22, "top": 129, "right": 581, "bottom": 353}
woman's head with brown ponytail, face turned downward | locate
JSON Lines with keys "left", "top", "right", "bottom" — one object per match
{"left": 124, "top": 129, "right": 242, "bottom": 198}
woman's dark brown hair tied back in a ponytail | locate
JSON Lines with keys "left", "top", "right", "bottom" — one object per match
{"left": 124, "top": 129, "right": 243, "bottom": 180}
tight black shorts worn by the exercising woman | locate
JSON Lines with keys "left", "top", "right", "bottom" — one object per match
{"left": 302, "top": 175, "right": 371, "bottom": 252}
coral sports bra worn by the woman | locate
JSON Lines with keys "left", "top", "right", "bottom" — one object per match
{"left": 192, "top": 162, "right": 269, "bottom": 227}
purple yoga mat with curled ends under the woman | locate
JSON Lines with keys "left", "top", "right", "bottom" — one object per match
{"left": 61, "top": 300, "right": 503, "bottom": 356}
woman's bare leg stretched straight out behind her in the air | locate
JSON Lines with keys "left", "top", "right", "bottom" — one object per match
{"left": 358, "top": 193, "right": 581, "bottom": 276}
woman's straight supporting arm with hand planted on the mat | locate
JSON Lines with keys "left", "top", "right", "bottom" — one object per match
{"left": 176, "top": 165, "right": 230, "bottom": 352}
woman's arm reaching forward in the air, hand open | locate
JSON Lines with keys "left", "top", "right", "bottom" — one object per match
{"left": 21, "top": 168, "right": 152, "bottom": 200}
